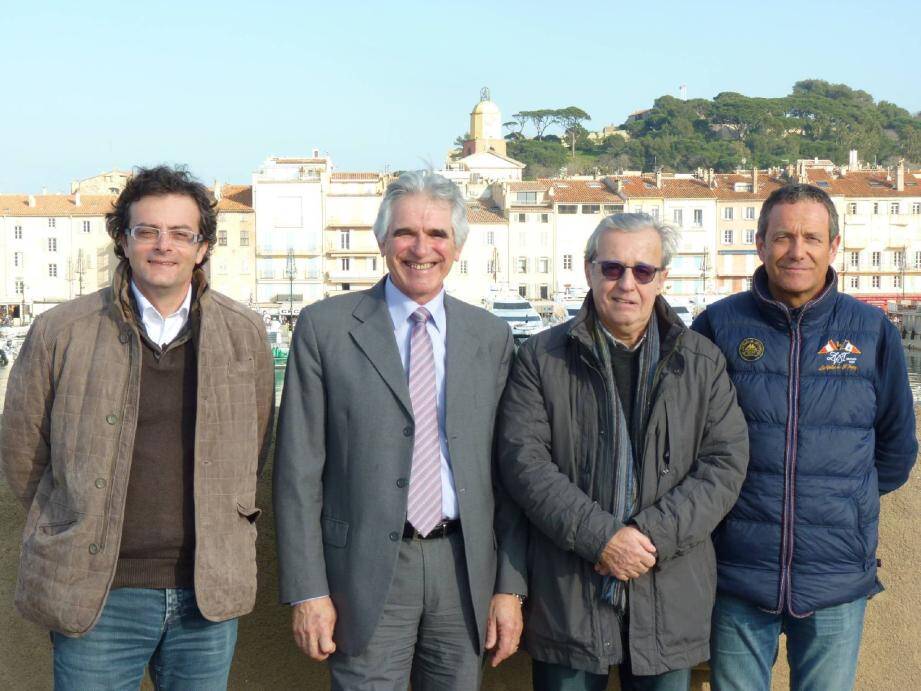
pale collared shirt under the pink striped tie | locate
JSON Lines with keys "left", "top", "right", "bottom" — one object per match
{"left": 384, "top": 276, "right": 459, "bottom": 519}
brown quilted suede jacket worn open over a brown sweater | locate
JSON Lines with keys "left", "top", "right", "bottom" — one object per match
{"left": 0, "top": 261, "right": 275, "bottom": 636}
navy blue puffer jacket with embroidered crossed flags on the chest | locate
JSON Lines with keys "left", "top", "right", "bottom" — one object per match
{"left": 693, "top": 267, "right": 918, "bottom": 616}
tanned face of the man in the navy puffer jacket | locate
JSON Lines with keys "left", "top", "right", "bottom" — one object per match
{"left": 757, "top": 200, "right": 841, "bottom": 308}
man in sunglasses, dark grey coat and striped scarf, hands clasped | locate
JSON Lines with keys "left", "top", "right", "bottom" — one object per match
{"left": 499, "top": 214, "right": 748, "bottom": 691}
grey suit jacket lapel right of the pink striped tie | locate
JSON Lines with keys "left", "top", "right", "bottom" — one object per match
{"left": 445, "top": 295, "right": 480, "bottom": 441}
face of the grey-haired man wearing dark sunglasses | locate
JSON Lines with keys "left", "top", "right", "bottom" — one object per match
{"left": 585, "top": 228, "right": 668, "bottom": 347}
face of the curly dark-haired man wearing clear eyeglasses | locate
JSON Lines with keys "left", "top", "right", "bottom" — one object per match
{"left": 120, "top": 194, "right": 208, "bottom": 314}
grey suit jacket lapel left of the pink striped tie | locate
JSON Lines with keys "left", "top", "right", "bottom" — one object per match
{"left": 350, "top": 278, "right": 413, "bottom": 416}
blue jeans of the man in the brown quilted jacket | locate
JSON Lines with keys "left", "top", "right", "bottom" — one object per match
{"left": 52, "top": 588, "right": 237, "bottom": 691}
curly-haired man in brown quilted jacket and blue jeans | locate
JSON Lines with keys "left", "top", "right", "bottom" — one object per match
{"left": 0, "top": 167, "right": 274, "bottom": 689}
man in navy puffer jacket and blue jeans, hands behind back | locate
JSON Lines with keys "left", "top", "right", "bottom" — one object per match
{"left": 693, "top": 185, "right": 918, "bottom": 691}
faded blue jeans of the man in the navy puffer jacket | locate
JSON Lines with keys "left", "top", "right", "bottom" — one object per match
{"left": 710, "top": 594, "right": 867, "bottom": 691}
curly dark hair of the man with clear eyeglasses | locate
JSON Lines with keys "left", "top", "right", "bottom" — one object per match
{"left": 106, "top": 166, "right": 217, "bottom": 268}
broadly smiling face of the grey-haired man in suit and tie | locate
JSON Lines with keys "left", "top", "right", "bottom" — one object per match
{"left": 381, "top": 194, "right": 460, "bottom": 305}
